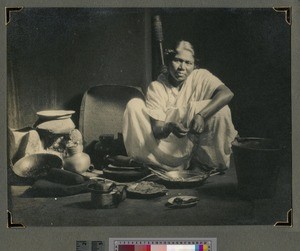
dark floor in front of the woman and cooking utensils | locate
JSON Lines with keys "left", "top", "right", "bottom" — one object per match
{"left": 10, "top": 151, "right": 292, "bottom": 226}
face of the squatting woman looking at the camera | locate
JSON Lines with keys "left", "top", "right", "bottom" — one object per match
{"left": 169, "top": 50, "right": 195, "bottom": 84}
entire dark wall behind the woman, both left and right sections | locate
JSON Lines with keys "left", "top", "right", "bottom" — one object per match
{"left": 7, "top": 8, "right": 291, "bottom": 143}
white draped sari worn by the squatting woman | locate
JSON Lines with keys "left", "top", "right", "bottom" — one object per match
{"left": 123, "top": 69, "right": 237, "bottom": 170}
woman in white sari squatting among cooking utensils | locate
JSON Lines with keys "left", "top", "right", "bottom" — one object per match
{"left": 123, "top": 41, "right": 237, "bottom": 171}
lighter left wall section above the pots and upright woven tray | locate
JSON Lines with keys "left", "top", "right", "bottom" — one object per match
{"left": 7, "top": 8, "right": 147, "bottom": 128}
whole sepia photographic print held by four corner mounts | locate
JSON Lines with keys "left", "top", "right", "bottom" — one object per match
{"left": 6, "top": 7, "right": 292, "bottom": 227}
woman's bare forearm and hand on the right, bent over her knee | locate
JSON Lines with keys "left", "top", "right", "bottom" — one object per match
{"left": 190, "top": 85, "right": 234, "bottom": 133}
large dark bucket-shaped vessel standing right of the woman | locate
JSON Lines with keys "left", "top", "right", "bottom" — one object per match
{"left": 232, "top": 137, "right": 284, "bottom": 199}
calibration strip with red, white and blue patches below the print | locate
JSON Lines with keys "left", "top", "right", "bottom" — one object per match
{"left": 110, "top": 238, "right": 216, "bottom": 251}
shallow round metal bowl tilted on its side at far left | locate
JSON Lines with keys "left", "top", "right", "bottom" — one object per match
{"left": 12, "top": 153, "right": 62, "bottom": 178}
